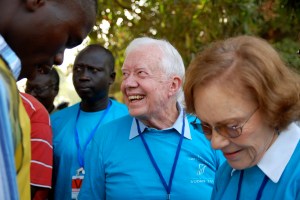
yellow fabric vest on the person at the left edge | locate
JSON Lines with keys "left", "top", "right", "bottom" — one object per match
{"left": 0, "top": 57, "right": 31, "bottom": 200}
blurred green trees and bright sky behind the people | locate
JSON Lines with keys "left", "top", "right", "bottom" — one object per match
{"left": 18, "top": 0, "right": 300, "bottom": 105}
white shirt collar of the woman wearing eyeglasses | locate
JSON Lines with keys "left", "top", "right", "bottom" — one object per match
{"left": 231, "top": 123, "right": 300, "bottom": 183}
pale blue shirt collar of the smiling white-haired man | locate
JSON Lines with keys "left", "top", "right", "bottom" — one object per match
{"left": 129, "top": 104, "right": 192, "bottom": 139}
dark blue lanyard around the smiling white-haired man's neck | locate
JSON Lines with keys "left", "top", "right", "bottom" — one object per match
{"left": 135, "top": 111, "right": 185, "bottom": 199}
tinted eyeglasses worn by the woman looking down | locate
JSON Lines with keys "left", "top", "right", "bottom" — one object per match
{"left": 201, "top": 107, "right": 259, "bottom": 138}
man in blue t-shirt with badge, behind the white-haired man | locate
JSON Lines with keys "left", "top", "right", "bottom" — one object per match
{"left": 51, "top": 44, "right": 128, "bottom": 199}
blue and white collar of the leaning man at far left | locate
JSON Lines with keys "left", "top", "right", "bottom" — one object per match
{"left": 0, "top": 35, "right": 21, "bottom": 80}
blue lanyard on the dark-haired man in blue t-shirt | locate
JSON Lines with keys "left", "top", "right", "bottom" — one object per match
{"left": 75, "top": 100, "right": 111, "bottom": 169}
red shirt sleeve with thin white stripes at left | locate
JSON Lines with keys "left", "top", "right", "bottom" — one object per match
{"left": 20, "top": 93, "right": 53, "bottom": 188}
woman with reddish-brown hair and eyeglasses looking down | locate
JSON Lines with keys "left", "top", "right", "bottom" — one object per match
{"left": 184, "top": 36, "right": 300, "bottom": 200}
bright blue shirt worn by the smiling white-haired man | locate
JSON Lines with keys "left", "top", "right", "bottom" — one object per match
{"left": 79, "top": 112, "right": 224, "bottom": 200}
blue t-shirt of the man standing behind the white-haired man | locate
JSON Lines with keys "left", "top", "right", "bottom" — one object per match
{"left": 51, "top": 100, "right": 128, "bottom": 199}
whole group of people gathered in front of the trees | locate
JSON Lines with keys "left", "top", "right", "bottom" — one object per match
{"left": 0, "top": 0, "right": 300, "bottom": 200}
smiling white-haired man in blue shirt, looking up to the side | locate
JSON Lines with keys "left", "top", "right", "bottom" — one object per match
{"left": 79, "top": 37, "right": 223, "bottom": 200}
